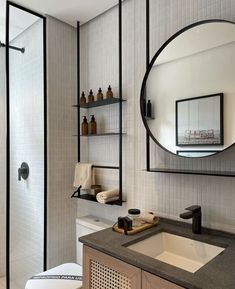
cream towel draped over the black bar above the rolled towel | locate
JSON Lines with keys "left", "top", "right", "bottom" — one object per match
{"left": 73, "top": 163, "right": 95, "bottom": 190}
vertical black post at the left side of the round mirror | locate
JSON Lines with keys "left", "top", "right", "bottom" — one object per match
{"left": 146, "top": 0, "right": 150, "bottom": 171}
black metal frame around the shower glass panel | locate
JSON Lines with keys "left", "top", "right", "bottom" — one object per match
{"left": 6, "top": 1, "right": 47, "bottom": 289}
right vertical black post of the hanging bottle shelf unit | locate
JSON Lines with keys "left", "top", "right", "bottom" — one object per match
{"left": 118, "top": 0, "right": 122, "bottom": 205}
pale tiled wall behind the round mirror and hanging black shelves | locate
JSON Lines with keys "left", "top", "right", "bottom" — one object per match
{"left": 77, "top": 0, "right": 235, "bottom": 232}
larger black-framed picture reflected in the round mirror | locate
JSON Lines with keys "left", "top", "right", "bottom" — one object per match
{"left": 175, "top": 93, "right": 224, "bottom": 146}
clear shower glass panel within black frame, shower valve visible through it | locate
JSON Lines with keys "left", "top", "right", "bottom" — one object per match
{"left": 9, "top": 3, "right": 45, "bottom": 289}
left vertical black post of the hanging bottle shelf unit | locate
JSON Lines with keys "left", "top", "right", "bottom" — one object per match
{"left": 77, "top": 21, "right": 81, "bottom": 197}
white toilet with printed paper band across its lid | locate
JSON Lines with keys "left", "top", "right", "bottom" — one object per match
{"left": 25, "top": 216, "right": 112, "bottom": 289}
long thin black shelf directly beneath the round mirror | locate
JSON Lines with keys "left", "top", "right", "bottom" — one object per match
{"left": 149, "top": 168, "right": 235, "bottom": 177}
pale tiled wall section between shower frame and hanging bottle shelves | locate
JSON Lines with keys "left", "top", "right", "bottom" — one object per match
{"left": 47, "top": 16, "right": 77, "bottom": 268}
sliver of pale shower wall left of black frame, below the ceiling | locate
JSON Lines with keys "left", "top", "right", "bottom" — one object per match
{"left": 0, "top": 48, "right": 6, "bottom": 277}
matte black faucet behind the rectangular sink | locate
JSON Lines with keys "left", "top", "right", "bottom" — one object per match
{"left": 180, "top": 205, "right": 202, "bottom": 234}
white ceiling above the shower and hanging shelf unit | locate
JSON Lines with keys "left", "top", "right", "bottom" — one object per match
{"left": 0, "top": 0, "right": 118, "bottom": 42}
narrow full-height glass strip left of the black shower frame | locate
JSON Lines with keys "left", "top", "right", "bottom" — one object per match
{"left": 0, "top": 1, "right": 6, "bottom": 289}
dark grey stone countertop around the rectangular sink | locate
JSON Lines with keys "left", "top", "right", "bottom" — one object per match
{"left": 80, "top": 218, "right": 235, "bottom": 289}
